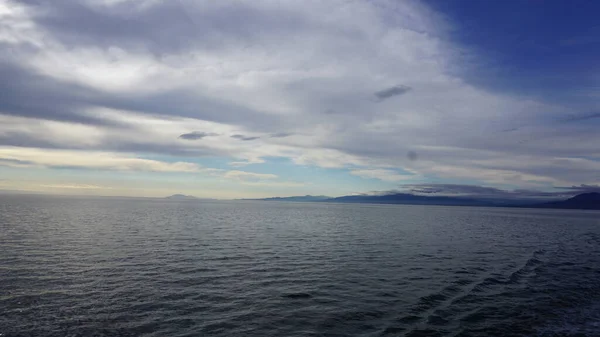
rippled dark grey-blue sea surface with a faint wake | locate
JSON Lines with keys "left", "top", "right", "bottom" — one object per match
{"left": 0, "top": 195, "right": 600, "bottom": 337}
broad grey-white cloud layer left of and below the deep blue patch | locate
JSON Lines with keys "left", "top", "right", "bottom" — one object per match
{"left": 0, "top": 0, "right": 600, "bottom": 194}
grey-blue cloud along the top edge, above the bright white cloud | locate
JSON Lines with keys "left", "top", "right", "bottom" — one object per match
{"left": 18, "top": 0, "right": 308, "bottom": 56}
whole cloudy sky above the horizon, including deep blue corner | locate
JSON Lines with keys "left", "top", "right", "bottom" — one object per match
{"left": 0, "top": 0, "right": 600, "bottom": 199}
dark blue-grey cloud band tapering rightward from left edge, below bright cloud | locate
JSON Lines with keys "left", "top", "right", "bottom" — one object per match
{"left": 0, "top": 48, "right": 283, "bottom": 131}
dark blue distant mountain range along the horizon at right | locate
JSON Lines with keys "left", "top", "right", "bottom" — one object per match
{"left": 245, "top": 193, "right": 600, "bottom": 210}
